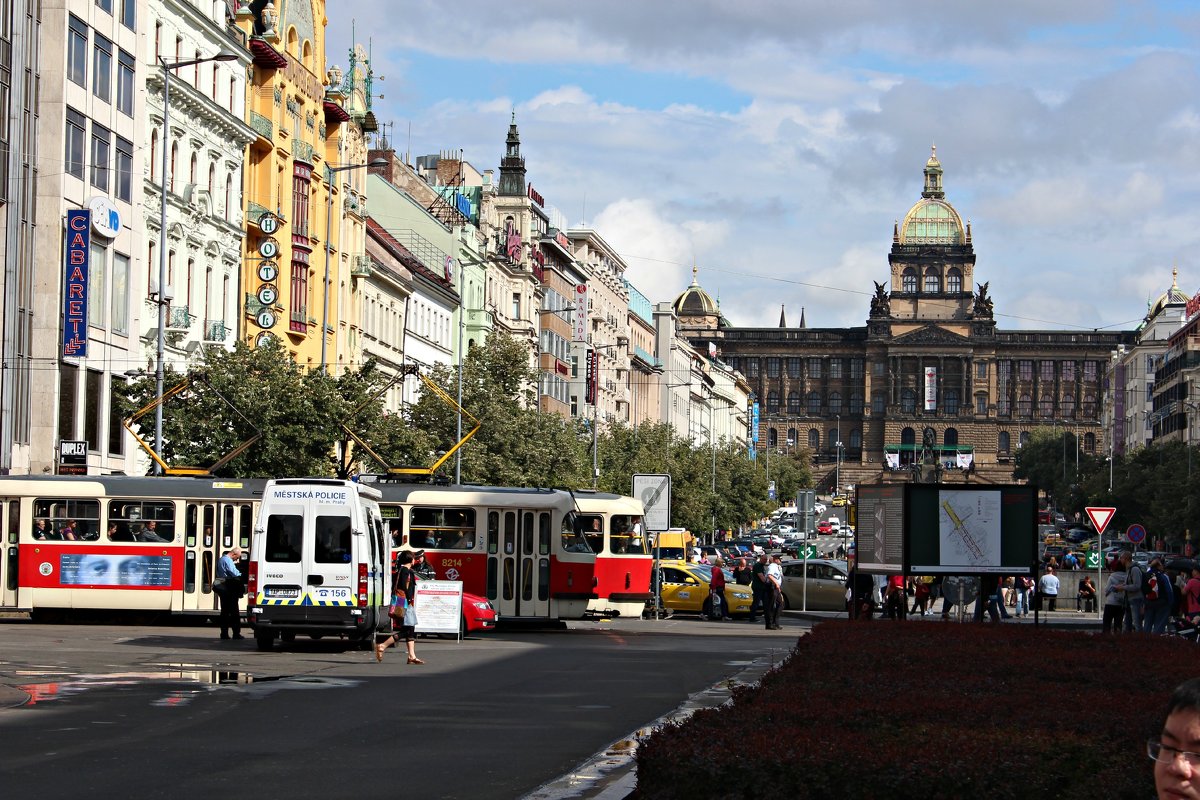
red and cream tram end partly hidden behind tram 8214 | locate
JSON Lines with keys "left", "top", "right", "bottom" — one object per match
{"left": 574, "top": 489, "right": 654, "bottom": 616}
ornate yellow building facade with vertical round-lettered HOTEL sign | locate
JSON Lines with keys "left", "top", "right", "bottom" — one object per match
{"left": 236, "top": 0, "right": 366, "bottom": 373}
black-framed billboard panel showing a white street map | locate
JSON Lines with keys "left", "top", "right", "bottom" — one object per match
{"left": 904, "top": 483, "right": 1038, "bottom": 576}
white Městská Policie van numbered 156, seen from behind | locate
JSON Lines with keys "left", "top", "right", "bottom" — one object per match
{"left": 247, "top": 479, "right": 391, "bottom": 650}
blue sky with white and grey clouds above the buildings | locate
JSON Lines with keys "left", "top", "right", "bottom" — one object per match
{"left": 326, "top": 0, "right": 1200, "bottom": 330}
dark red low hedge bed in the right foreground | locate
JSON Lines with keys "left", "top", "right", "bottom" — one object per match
{"left": 637, "top": 621, "right": 1200, "bottom": 800}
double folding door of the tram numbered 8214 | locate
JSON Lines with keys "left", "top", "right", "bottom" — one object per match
{"left": 487, "top": 509, "right": 551, "bottom": 618}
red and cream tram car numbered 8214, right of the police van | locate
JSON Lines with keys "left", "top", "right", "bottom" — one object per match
{"left": 374, "top": 481, "right": 596, "bottom": 620}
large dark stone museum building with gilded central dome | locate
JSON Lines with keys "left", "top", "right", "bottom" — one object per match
{"left": 674, "top": 151, "right": 1135, "bottom": 491}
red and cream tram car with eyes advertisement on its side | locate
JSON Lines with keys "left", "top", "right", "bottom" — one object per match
{"left": 0, "top": 475, "right": 265, "bottom": 620}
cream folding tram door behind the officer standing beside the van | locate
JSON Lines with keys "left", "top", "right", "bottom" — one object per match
{"left": 184, "top": 503, "right": 254, "bottom": 612}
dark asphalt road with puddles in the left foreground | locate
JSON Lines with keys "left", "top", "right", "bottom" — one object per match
{"left": 0, "top": 615, "right": 808, "bottom": 800}
